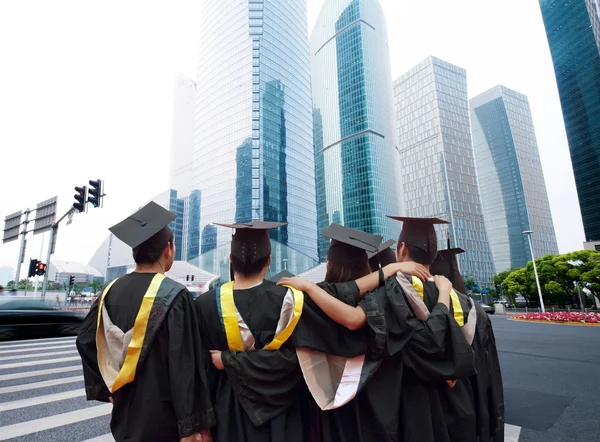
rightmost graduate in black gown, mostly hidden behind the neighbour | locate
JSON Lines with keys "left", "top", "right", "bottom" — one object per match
{"left": 431, "top": 248, "right": 504, "bottom": 442}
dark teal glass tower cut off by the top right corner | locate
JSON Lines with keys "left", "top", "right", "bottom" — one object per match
{"left": 540, "top": 0, "right": 600, "bottom": 249}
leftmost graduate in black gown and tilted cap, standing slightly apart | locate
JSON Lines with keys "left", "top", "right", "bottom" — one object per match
{"left": 77, "top": 202, "right": 216, "bottom": 442}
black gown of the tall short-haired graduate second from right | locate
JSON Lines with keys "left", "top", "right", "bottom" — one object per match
{"left": 361, "top": 278, "right": 475, "bottom": 442}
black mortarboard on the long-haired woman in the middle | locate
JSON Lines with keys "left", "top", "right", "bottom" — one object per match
{"left": 321, "top": 224, "right": 383, "bottom": 265}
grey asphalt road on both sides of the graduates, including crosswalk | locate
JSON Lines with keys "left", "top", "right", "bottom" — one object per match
{"left": 0, "top": 316, "right": 600, "bottom": 442}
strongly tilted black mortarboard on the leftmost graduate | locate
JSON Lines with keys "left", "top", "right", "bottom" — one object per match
{"left": 108, "top": 201, "right": 177, "bottom": 249}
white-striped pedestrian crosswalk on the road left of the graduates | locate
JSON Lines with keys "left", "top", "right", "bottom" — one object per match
{"left": 0, "top": 337, "right": 114, "bottom": 442}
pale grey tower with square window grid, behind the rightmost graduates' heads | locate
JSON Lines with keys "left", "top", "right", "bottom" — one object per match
{"left": 394, "top": 57, "right": 495, "bottom": 287}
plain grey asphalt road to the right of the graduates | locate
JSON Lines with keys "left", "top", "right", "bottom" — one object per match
{"left": 492, "top": 316, "right": 600, "bottom": 442}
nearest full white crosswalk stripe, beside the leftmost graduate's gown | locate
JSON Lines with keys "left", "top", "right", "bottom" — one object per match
{"left": 0, "top": 404, "right": 112, "bottom": 440}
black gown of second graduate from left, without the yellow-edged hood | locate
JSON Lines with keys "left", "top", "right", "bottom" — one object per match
{"left": 195, "top": 281, "right": 304, "bottom": 442}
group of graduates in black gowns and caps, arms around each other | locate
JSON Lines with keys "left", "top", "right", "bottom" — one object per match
{"left": 77, "top": 203, "right": 504, "bottom": 442}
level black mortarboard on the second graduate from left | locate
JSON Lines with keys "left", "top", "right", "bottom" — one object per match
{"left": 213, "top": 221, "right": 287, "bottom": 264}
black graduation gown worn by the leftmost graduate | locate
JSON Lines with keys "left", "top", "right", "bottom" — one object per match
{"left": 77, "top": 273, "right": 215, "bottom": 442}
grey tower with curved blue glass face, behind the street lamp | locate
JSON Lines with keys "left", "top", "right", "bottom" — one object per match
{"left": 470, "top": 86, "right": 558, "bottom": 272}
